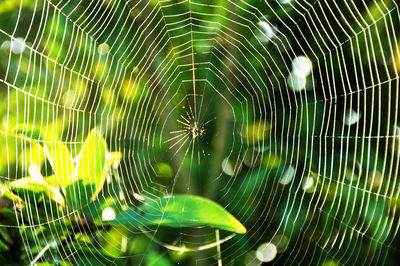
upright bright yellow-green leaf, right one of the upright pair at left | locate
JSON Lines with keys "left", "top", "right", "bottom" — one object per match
{"left": 65, "top": 130, "right": 107, "bottom": 209}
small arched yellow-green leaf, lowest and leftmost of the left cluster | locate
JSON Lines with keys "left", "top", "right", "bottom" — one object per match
{"left": 10, "top": 176, "right": 64, "bottom": 206}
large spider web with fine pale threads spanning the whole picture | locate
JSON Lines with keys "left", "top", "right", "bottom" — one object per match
{"left": 0, "top": 0, "right": 400, "bottom": 265}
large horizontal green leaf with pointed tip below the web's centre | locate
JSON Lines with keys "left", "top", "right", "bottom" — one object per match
{"left": 107, "top": 195, "right": 246, "bottom": 234}
